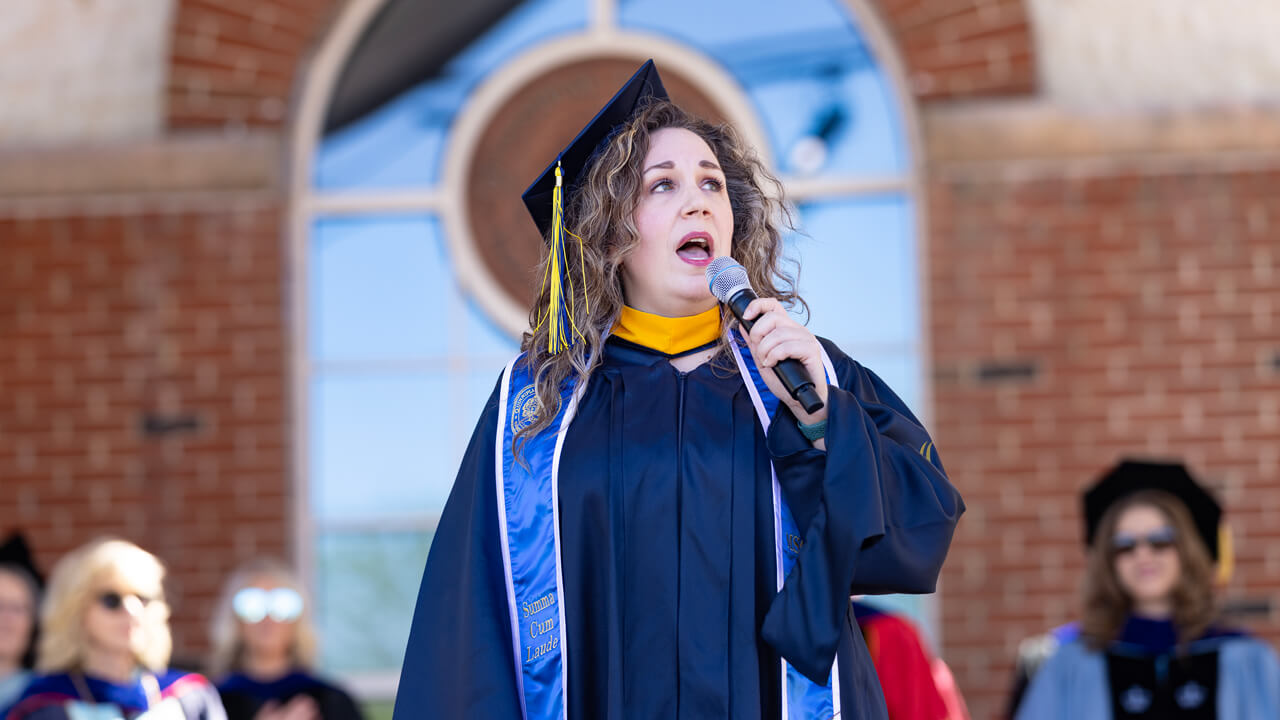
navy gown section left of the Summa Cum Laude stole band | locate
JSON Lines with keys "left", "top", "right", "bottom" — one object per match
{"left": 393, "top": 380, "right": 521, "bottom": 720}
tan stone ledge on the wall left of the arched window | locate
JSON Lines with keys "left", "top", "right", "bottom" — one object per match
{"left": 0, "top": 132, "right": 283, "bottom": 200}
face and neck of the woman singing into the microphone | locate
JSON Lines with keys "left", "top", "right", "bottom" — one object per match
{"left": 622, "top": 128, "right": 733, "bottom": 318}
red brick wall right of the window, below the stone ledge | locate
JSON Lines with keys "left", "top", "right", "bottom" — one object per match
{"left": 928, "top": 160, "right": 1280, "bottom": 719}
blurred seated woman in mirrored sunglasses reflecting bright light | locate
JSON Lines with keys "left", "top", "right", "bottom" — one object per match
{"left": 209, "top": 559, "right": 362, "bottom": 720}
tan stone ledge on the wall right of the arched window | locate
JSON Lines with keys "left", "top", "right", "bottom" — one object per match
{"left": 922, "top": 100, "right": 1280, "bottom": 167}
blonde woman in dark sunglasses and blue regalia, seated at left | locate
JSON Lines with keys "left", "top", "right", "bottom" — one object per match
{"left": 6, "top": 539, "right": 227, "bottom": 720}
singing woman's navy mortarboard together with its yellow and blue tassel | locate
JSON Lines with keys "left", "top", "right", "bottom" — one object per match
{"left": 521, "top": 60, "right": 667, "bottom": 355}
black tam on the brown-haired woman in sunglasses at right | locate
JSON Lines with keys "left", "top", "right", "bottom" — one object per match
{"left": 1084, "top": 460, "right": 1222, "bottom": 561}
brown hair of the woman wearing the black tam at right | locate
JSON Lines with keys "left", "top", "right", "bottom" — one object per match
{"left": 1080, "top": 491, "right": 1217, "bottom": 650}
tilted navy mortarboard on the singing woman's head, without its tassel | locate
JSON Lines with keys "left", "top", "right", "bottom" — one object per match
{"left": 521, "top": 60, "right": 667, "bottom": 238}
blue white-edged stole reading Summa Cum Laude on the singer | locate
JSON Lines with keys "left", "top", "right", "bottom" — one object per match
{"left": 494, "top": 333, "right": 840, "bottom": 720}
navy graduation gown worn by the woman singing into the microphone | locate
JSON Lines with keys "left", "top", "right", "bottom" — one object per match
{"left": 396, "top": 337, "right": 964, "bottom": 720}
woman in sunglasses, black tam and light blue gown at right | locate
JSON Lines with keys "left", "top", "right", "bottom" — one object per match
{"left": 1016, "top": 461, "right": 1280, "bottom": 720}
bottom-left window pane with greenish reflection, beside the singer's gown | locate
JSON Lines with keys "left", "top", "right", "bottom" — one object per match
{"left": 316, "top": 532, "right": 433, "bottom": 673}
